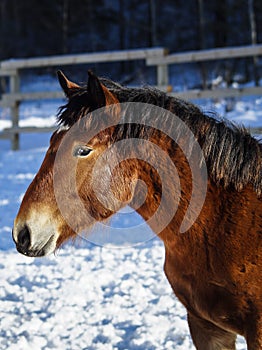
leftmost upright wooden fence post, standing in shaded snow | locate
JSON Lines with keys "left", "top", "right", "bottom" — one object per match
{"left": 10, "top": 70, "right": 20, "bottom": 151}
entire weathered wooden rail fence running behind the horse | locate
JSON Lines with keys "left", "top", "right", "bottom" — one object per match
{"left": 0, "top": 45, "right": 262, "bottom": 150}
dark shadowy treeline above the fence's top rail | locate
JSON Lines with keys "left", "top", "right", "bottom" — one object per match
{"left": 0, "top": 0, "right": 262, "bottom": 83}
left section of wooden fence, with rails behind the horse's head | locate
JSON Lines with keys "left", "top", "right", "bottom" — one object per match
{"left": 0, "top": 48, "right": 167, "bottom": 150}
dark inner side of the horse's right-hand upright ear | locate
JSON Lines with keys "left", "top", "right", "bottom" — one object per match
{"left": 87, "top": 70, "right": 106, "bottom": 109}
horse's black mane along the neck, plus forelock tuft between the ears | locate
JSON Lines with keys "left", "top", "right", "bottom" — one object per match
{"left": 58, "top": 78, "right": 262, "bottom": 195}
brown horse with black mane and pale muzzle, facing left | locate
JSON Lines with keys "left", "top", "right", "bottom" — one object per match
{"left": 13, "top": 72, "right": 262, "bottom": 350}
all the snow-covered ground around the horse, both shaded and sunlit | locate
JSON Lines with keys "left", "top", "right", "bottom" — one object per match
{"left": 0, "top": 75, "right": 262, "bottom": 350}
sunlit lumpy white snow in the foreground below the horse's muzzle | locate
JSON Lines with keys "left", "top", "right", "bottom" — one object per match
{"left": 0, "top": 244, "right": 190, "bottom": 349}
